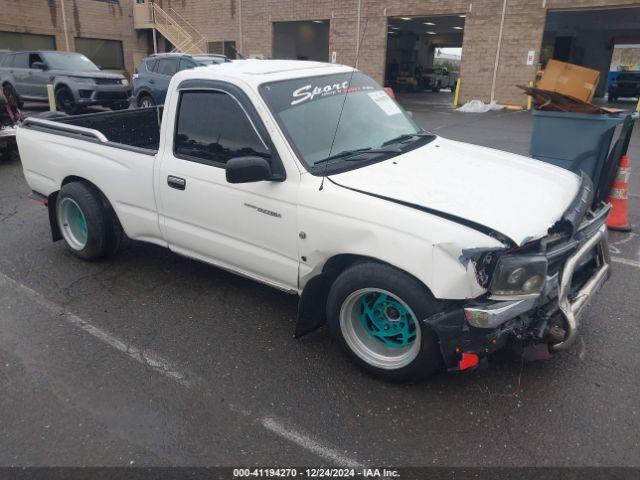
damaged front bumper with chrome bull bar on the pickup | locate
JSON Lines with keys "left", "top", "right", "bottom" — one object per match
{"left": 425, "top": 206, "right": 610, "bottom": 370}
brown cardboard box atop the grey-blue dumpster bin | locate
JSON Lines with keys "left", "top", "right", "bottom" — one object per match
{"left": 536, "top": 60, "right": 600, "bottom": 102}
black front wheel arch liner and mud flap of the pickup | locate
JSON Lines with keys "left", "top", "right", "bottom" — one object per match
{"left": 294, "top": 253, "right": 430, "bottom": 338}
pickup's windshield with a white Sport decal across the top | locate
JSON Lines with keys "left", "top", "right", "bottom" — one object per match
{"left": 260, "top": 72, "right": 422, "bottom": 172}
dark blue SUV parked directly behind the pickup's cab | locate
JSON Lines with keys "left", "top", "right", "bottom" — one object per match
{"left": 131, "top": 53, "right": 231, "bottom": 108}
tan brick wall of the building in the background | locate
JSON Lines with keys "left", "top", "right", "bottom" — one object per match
{"left": 0, "top": 0, "right": 640, "bottom": 105}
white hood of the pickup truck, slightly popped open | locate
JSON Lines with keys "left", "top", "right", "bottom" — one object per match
{"left": 331, "top": 137, "right": 580, "bottom": 245}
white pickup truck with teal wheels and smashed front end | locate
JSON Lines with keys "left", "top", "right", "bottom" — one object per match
{"left": 17, "top": 60, "right": 610, "bottom": 379}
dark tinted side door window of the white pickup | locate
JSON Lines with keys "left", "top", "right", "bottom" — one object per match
{"left": 174, "top": 91, "right": 270, "bottom": 166}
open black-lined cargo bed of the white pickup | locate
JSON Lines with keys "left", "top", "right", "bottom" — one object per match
{"left": 24, "top": 107, "right": 162, "bottom": 154}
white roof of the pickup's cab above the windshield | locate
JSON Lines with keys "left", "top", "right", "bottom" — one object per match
{"left": 178, "top": 59, "right": 353, "bottom": 86}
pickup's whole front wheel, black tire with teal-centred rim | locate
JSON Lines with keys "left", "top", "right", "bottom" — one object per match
{"left": 327, "top": 262, "right": 444, "bottom": 381}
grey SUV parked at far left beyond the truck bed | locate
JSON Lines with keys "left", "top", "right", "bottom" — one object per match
{"left": 0, "top": 51, "right": 130, "bottom": 114}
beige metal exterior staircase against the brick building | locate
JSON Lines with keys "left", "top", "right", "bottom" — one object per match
{"left": 134, "top": 1, "right": 207, "bottom": 54}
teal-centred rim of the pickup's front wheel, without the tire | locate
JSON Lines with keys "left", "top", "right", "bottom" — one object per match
{"left": 340, "top": 288, "right": 421, "bottom": 370}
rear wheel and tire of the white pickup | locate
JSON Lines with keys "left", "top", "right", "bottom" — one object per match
{"left": 56, "top": 182, "right": 123, "bottom": 261}
